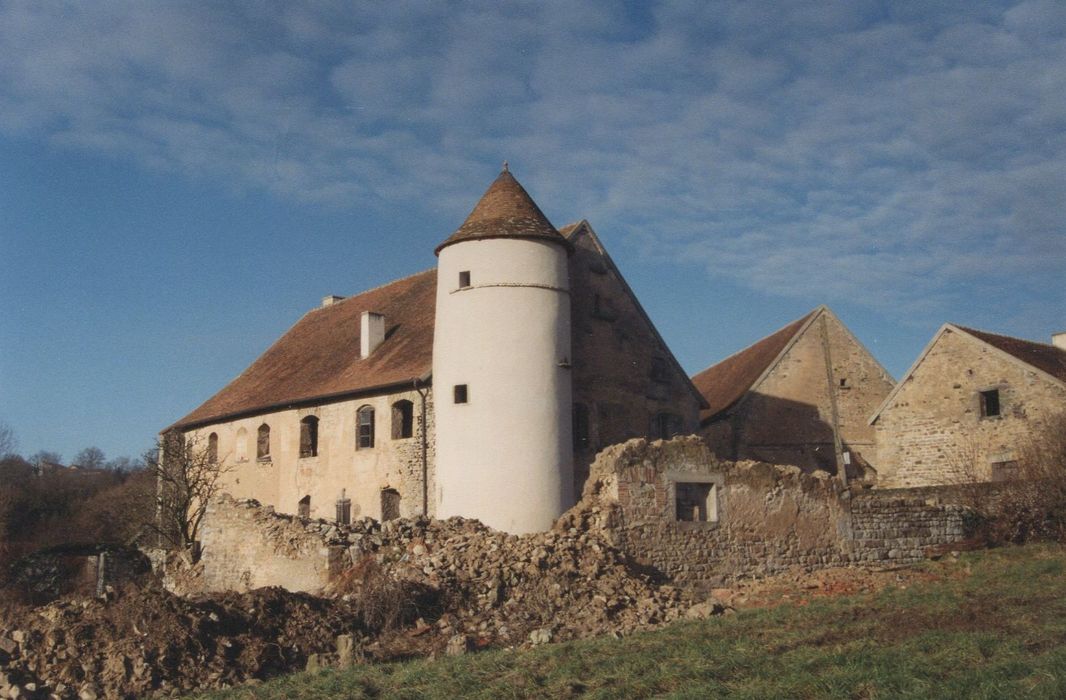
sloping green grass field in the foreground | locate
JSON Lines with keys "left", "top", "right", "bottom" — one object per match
{"left": 194, "top": 546, "right": 1066, "bottom": 700}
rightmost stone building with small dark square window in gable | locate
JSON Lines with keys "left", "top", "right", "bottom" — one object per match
{"left": 870, "top": 323, "right": 1066, "bottom": 487}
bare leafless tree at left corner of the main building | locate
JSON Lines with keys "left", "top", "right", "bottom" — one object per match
{"left": 144, "top": 432, "right": 231, "bottom": 551}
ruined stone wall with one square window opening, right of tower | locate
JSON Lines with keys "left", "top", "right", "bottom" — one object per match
{"left": 564, "top": 438, "right": 965, "bottom": 586}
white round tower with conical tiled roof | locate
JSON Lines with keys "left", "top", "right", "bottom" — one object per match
{"left": 433, "top": 164, "right": 574, "bottom": 534}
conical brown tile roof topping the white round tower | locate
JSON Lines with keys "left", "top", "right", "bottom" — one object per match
{"left": 435, "top": 167, "right": 570, "bottom": 255}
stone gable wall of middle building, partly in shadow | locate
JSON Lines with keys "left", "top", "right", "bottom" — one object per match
{"left": 700, "top": 307, "right": 894, "bottom": 475}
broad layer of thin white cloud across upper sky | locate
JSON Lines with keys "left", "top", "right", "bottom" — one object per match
{"left": 0, "top": 1, "right": 1066, "bottom": 321}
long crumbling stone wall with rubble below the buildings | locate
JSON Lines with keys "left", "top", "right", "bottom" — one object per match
{"left": 199, "top": 437, "right": 966, "bottom": 598}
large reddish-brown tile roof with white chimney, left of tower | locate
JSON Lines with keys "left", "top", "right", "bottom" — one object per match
{"left": 167, "top": 270, "right": 437, "bottom": 429}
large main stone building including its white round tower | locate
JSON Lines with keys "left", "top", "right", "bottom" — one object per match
{"left": 167, "top": 168, "right": 706, "bottom": 532}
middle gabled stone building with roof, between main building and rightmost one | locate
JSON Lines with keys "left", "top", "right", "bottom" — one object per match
{"left": 693, "top": 306, "right": 894, "bottom": 476}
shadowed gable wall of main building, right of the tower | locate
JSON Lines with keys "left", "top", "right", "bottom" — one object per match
{"left": 569, "top": 226, "right": 699, "bottom": 495}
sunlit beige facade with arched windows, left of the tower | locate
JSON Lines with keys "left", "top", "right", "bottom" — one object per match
{"left": 191, "top": 390, "right": 435, "bottom": 520}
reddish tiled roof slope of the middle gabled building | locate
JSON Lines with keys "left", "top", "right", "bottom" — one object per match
{"left": 692, "top": 310, "right": 818, "bottom": 423}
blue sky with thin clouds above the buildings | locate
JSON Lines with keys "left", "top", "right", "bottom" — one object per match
{"left": 0, "top": 0, "right": 1066, "bottom": 458}
